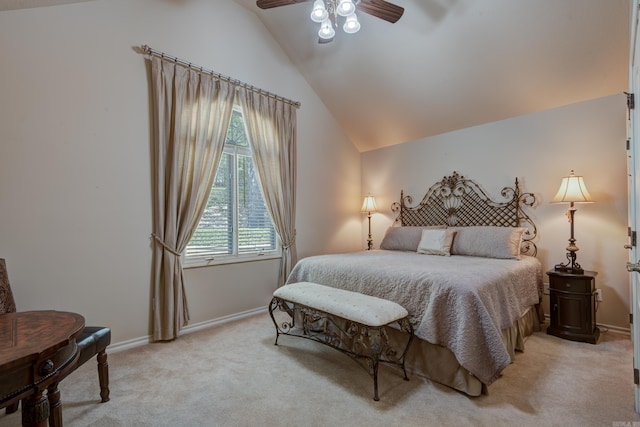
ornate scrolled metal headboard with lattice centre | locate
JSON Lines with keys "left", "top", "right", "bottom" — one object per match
{"left": 391, "top": 172, "right": 538, "bottom": 256}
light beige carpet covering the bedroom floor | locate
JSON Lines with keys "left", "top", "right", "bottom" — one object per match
{"left": 0, "top": 314, "right": 640, "bottom": 427}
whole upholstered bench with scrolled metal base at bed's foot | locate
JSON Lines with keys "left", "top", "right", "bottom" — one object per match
{"left": 269, "top": 282, "right": 413, "bottom": 400}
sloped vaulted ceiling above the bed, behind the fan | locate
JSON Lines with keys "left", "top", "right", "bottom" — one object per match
{"left": 235, "top": 0, "right": 630, "bottom": 151}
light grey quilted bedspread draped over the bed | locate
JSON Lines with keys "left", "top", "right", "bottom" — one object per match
{"left": 287, "top": 250, "right": 542, "bottom": 385}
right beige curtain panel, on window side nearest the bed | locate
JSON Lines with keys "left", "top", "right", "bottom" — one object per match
{"left": 239, "top": 88, "right": 297, "bottom": 286}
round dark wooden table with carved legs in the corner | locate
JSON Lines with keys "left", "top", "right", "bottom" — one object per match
{"left": 0, "top": 310, "right": 84, "bottom": 426}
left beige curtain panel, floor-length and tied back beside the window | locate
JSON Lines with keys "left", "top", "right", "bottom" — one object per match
{"left": 151, "top": 56, "right": 235, "bottom": 341}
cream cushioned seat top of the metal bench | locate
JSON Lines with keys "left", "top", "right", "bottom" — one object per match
{"left": 273, "top": 282, "right": 409, "bottom": 327}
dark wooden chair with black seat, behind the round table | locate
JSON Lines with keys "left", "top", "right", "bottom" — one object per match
{"left": 0, "top": 258, "right": 111, "bottom": 427}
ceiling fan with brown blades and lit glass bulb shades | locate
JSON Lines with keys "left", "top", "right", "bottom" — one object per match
{"left": 256, "top": 0, "right": 404, "bottom": 43}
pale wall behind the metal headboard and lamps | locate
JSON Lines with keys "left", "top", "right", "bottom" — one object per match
{"left": 362, "top": 94, "right": 630, "bottom": 328}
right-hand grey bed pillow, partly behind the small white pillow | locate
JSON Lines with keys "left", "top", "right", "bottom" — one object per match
{"left": 451, "top": 226, "right": 527, "bottom": 259}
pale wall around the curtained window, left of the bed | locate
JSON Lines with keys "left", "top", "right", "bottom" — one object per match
{"left": 0, "top": 0, "right": 361, "bottom": 343}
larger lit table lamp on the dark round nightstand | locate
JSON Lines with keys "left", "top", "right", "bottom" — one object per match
{"left": 551, "top": 170, "right": 593, "bottom": 274}
